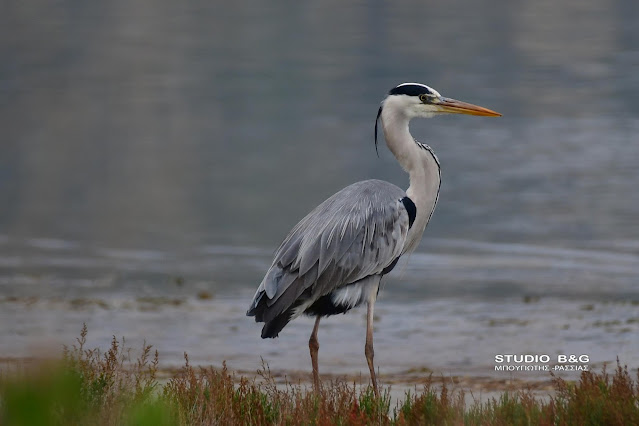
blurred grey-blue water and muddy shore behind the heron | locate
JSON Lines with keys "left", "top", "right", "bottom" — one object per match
{"left": 0, "top": 0, "right": 639, "bottom": 377}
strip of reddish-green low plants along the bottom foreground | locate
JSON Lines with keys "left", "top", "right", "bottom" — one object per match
{"left": 0, "top": 326, "right": 639, "bottom": 426}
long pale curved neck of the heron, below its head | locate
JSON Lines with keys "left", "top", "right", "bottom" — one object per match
{"left": 381, "top": 105, "right": 440, "bottom": 252}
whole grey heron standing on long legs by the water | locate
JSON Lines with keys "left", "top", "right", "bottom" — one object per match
{"left": 246, "top": 83, "right": 501, "bottom": 395}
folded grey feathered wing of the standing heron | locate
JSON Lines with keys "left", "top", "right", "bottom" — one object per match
{"left": 247, "top": 180, "right": 409, "bottom": 321}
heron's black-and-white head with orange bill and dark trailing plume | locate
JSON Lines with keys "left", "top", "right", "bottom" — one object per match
{"left": 375, "top": 83, "right": 501, "bottom": 153}
